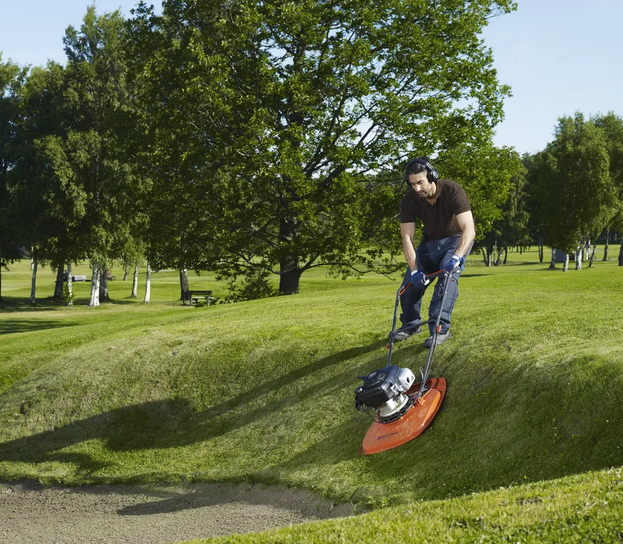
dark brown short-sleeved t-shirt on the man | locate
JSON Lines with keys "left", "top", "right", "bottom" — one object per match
{"left": 400, "top": 179, "right": 472, "bottom": 241}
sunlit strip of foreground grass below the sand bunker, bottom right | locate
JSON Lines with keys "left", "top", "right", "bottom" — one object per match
{"left": 193, "top": 468, "right": 623, "bottom": 544}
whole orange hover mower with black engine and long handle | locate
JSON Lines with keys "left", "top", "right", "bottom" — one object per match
{"left": 355, "top": 270, "right": 450, "bottom": 455}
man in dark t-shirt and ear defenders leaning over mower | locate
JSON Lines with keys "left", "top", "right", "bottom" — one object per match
{"left": 394, "top": 157, "right": 476, "bottom": 347}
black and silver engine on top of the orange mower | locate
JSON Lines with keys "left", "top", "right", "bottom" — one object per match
{"left": 355, "top": 365, "right": 415, "bottom": 423}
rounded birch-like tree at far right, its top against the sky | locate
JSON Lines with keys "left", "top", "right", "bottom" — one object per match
{"left": 537, "top": 113, "right": 617, "bottom": 269}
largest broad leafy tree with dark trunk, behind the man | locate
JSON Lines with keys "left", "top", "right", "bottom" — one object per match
{"left": 135, "top": 0, "right": 514, "bottom": 294}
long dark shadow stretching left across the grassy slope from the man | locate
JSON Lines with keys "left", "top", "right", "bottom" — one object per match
{"left": 0, "top": 340, "right": 385, "bottom": 473}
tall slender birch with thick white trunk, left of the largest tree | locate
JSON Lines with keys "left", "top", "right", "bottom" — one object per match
{"left": 60, "top": 6, "right": 141, "bottom": 306}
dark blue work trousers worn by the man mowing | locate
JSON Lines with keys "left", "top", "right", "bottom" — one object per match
{"left": 400, "top": 234, "right": 471, "bottom": 335}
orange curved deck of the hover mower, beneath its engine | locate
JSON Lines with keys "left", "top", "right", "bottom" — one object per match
{"left": 360, "top": 378, "right": 446, "bottom": 455}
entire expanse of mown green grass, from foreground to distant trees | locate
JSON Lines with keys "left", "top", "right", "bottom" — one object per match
{"left": 0, "top": 253, "right": 623, "bottom": 542}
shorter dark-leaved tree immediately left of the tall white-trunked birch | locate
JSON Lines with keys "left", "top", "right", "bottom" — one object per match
{"left": 9, "top": 62, "right": 87, "bottom": 300}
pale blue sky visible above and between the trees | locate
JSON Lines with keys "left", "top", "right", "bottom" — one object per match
{"left": 0, "top": 0, "right": 623, "bottom": 154}
